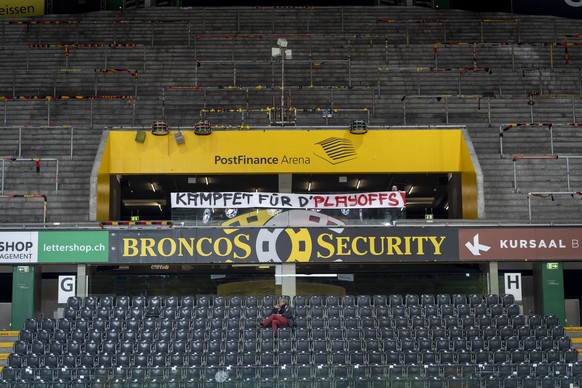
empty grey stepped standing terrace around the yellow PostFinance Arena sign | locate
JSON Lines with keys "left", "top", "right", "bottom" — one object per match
{"left": 0, "top": 7, "right": 582, "bottom": 222}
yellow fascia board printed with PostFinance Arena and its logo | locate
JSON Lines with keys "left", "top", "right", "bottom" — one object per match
{"left": 109, "top": 129, "right": 474, "bottom": 174}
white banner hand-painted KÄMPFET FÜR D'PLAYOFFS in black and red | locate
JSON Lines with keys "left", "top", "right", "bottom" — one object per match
{"left": 171, "top": 191, "right": 406, "bottom": 209}
